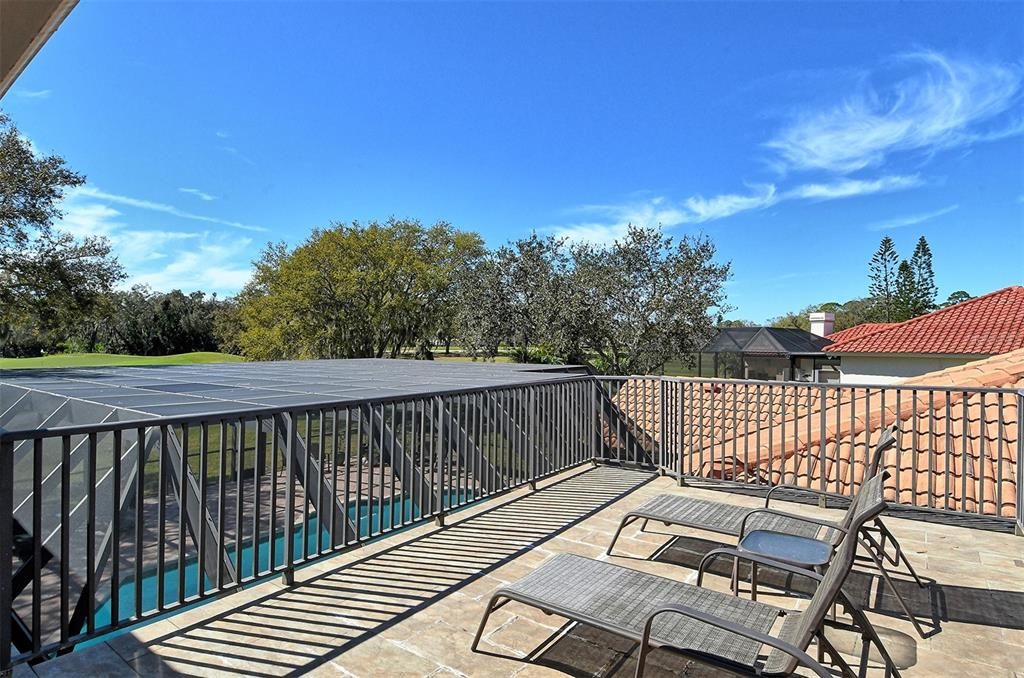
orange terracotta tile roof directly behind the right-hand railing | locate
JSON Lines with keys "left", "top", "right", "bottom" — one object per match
{"left": 608, "top": 349, "right": 1024, "bottom": 517}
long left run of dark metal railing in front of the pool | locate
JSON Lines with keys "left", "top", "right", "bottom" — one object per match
{"left": 0, "top": 377, "right": 600, "bottom": 668}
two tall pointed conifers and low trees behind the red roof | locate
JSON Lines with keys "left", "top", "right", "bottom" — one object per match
{"left": 769, "top": 236, "right": 974, "bottom": 332}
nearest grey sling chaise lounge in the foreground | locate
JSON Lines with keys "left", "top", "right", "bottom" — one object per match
{"left": 472, "top": 475, "right": 899, "bottom": 677}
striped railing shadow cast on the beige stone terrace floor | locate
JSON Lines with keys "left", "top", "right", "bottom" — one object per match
{"left": 112, "top": 467, "right": 655, "bottom": 675}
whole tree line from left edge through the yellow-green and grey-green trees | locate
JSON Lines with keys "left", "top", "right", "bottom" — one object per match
{"left": 0, "top": 117, "right": 729, "bottom": 373}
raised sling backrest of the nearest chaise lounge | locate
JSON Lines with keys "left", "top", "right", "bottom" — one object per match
{"left": 764, "top": 472, "right": 888, "bottom": 675}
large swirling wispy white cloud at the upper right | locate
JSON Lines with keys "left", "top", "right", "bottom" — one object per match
{"left": 765, "top": 51, "right": 1024, "bottom": 174}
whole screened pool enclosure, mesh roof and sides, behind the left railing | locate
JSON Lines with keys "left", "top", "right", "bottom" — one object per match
{"left": 0, "top": 359, "right": 610, "bottom": 653}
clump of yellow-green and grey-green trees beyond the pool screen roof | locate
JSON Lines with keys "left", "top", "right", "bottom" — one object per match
{"left": 232, "top": 219, "right": 729, "bottom": 373}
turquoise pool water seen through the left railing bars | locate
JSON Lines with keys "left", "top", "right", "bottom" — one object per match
{"left": 91, "top": 491, "right": 475, "bottom": 630}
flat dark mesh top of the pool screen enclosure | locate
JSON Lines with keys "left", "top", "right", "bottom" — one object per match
{"left": 0, "top": 358, "right": 587, "bottom": 432}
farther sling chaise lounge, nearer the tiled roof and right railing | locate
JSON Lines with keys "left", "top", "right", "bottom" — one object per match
{"left": 605, "top": 424, "right": 928, "bottom": 638}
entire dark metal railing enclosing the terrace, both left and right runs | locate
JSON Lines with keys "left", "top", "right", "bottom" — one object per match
{"left": 0, "top": 376, "right": 1024, "bottom": 670}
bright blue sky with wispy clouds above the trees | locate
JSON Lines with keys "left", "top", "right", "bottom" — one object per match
{"left": 0, "top": 0, "right": 1024, "bottom": 322}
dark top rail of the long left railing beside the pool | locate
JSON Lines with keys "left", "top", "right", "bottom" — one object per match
{"left": 0, "top": 373, "right": 594, "bottom": 442}
